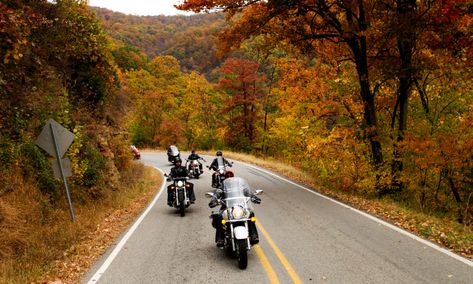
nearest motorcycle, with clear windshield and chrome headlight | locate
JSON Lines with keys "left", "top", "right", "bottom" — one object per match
{"left": 205, "top": 177, "right": 263, "bottom": 269}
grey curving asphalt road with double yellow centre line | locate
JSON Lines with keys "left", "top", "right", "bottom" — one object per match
{"left": 82, "top": 152, "right": 473, "bottom": 283}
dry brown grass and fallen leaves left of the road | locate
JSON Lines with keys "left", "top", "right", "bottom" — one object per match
{"left": 0, "top": 164, "right": 161, "bottom": 283}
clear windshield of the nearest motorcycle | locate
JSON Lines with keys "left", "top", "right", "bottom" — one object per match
{"left": 223, "top": 177, "right": 252, "bottom": 209}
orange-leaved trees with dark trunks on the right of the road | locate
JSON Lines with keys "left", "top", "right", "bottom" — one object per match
{"left": 171, "top": 0, "right": 472, "bottom": 222}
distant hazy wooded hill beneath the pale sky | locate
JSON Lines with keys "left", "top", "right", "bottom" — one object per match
{"left": 92, "top": 7, "right": 224, "bottom": 74}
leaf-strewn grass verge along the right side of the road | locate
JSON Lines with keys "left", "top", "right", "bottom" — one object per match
{"left": 219, "top": 151, "right": 473, "bottom": 259}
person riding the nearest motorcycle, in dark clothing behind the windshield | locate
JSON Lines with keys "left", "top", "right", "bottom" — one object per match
{"left": 209, "top": 175, "right": 261, "bottom": 247}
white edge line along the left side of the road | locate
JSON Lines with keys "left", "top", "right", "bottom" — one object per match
{"left": 87, "top": 167, "right": 166, "bottom": 284}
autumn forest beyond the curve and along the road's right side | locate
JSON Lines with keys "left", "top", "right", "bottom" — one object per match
{"left": 109, "top": 0, "right": 473, "bottom": 224}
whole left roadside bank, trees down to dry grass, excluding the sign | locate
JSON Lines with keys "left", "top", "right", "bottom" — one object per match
{"left": 0, "top": 0, "right": 161, "bottom": 283}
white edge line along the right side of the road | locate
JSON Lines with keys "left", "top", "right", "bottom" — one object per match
{"left": 239, "top": 161, "right": 473, "bottom": 267}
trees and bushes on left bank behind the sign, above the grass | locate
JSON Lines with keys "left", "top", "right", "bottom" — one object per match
{"left": 0, "top": 0, "right": 127, "bottom": 199}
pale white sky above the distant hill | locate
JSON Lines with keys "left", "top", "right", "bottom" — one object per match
{"left": 89, "top": 0, "right": 193, "bottom": 16}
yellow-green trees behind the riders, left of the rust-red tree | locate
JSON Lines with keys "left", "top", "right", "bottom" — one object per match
{"left": 123, "top": 56, "right": 226, "bottom": 149}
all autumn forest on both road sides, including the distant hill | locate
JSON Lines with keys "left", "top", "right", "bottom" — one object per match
{"left": 0, "top": 0, "right": 473, "bottom": 279}
